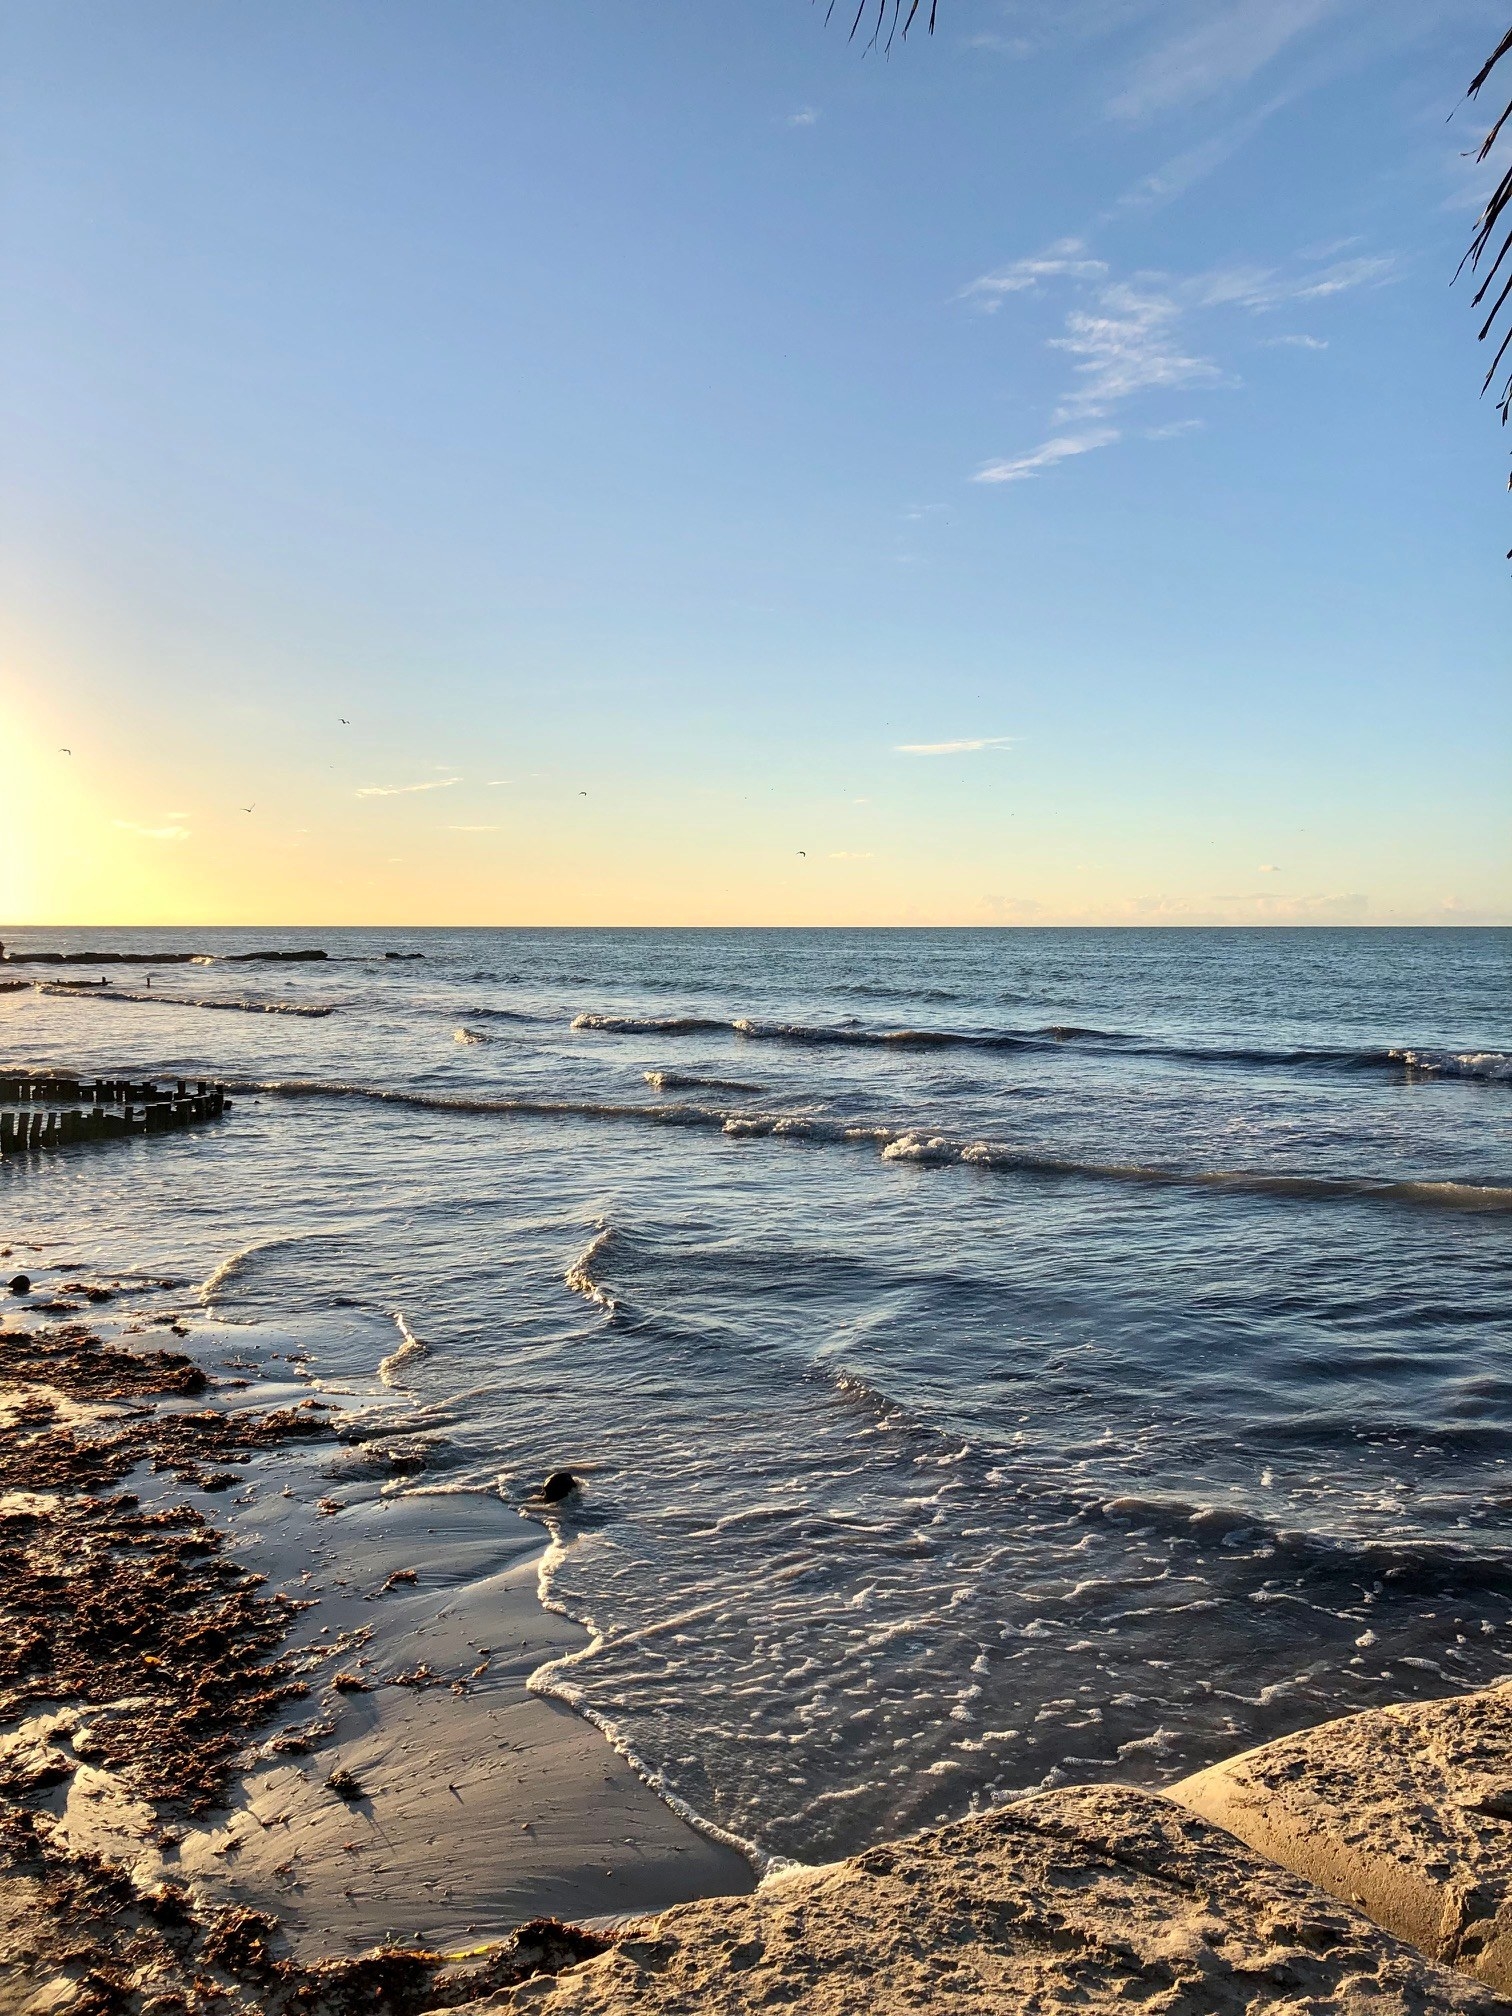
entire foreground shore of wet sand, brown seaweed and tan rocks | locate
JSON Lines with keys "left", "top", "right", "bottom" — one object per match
{"left": 0, "top": 1282, "right": 1512, "bottom": 2016}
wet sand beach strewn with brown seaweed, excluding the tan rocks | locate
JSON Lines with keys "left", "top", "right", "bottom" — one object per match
{"left": 0, "top": 1286, "right": 754, "bottom": 2010}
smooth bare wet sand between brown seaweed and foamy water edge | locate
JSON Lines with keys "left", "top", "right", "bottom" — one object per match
{"left": 177, "top": 1496, "right": 754, "bottom": 1954}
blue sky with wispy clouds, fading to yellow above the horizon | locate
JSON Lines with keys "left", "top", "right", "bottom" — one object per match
{"left": 0, "top": 0, "right": 1512, "bottom": 925}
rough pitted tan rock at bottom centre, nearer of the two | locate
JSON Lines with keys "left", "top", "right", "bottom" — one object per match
{"left": 458, "top": 1786, "right": 1506, "bottom": 2016}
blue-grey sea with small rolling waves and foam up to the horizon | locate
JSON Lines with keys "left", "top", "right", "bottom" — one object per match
{"left": 0, "top": 931, "right": 1512, "bottom": 1861}
